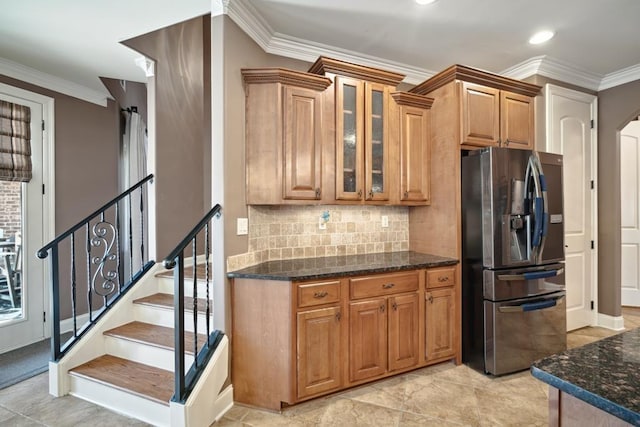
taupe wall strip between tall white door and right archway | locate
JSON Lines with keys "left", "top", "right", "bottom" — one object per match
{"left": 597, "top": 80, "right": 640, "bottom": 316}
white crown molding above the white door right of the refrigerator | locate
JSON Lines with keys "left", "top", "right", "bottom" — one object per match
{"left": 500, "top": 55, "right": 603, "bottom": 91}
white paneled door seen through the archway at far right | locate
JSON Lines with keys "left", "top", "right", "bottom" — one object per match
{"left": 620, "top": 120, "right": 640, "bottom": 307}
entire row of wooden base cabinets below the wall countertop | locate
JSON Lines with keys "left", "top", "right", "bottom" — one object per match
{"left": 231, "top": 265, "right": 460, "bottom": 410}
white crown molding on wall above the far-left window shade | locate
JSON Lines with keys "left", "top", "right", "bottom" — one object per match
{"left": 0, "top": 58, "right": 109, "bottom": 107}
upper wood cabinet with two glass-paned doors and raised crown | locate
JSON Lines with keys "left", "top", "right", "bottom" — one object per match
{"left": 309, "top": 57, "right": 404, "bottom": 202}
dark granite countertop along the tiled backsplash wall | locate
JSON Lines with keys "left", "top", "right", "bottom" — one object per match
{"left": 227, "top": 252, "right": 458, "bottom": 281}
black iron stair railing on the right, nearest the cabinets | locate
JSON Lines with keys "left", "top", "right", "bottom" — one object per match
{"left": 163, "top": 205, "right": 224, "bottom": 403}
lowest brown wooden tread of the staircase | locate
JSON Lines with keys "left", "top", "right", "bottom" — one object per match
{"left": 69, "top": 354, "right": 173, "bottom": 406}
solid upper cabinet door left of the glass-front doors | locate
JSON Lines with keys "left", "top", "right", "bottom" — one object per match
{"left": 284, "top": 87, "right": 322, "bottom": 199}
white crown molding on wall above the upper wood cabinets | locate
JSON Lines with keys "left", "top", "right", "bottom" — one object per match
{"left": 224, "top": 0, "right": 435, "bottom": 84}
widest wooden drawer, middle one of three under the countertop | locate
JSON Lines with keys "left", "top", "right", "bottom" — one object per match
{"left": 349, "top": 270, "right": 420, "bottom": 299}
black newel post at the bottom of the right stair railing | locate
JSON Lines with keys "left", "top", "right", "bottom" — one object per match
{"left": 173, "top": 253, "right": 185, "bottom": 402}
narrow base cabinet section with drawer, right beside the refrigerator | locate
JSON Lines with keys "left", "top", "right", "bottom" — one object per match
{"left": 425, "top": 267, "right": 458, "bottom": 360}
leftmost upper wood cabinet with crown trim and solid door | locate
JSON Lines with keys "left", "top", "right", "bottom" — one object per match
{"left": 242, "top": 68, "right": 333, "bottom": 204}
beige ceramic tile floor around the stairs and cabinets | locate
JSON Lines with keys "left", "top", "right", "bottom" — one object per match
{"left": 0, "top": 308, "right": 640, "bottom": 427}
